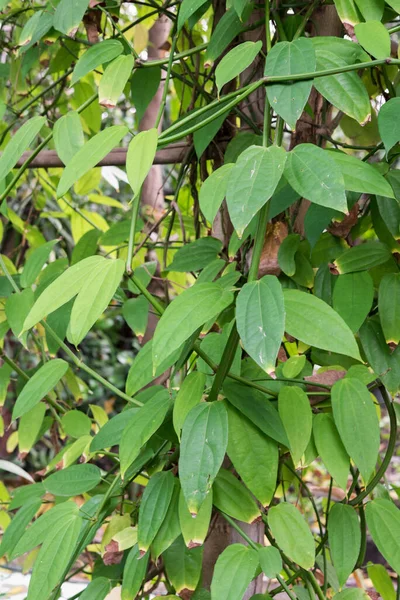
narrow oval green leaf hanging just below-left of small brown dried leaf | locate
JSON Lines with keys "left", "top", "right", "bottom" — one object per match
{"left": 278, "top": 386, "right": 312, "bottom": 467}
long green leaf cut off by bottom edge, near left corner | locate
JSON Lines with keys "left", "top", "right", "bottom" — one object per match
{"left": 27, "top": 515, "right": 83, "bottom": 600}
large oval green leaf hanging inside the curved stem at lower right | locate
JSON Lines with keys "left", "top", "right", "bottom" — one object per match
{"left": 331, "top": 377, "right": 380, "bottom": 482}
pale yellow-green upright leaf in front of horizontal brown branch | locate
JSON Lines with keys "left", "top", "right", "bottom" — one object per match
{"left": 126, "top": 129, "right": 158, "bottom": 196}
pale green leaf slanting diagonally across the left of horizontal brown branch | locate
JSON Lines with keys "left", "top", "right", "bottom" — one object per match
{"left": 57, "top": 126, "right": 128, "bottom": 198}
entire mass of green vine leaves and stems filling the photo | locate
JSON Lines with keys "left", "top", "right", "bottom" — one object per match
{"left": 0, "top": 0, "right": 400, "bottom": 600}
